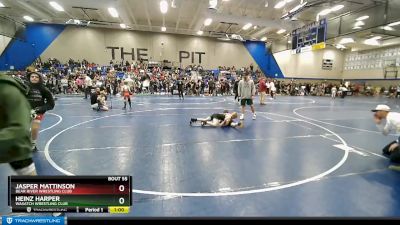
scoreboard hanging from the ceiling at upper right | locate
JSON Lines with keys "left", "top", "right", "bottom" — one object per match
{"left": 292, "top": 19, "right": 328, "bottom": 53}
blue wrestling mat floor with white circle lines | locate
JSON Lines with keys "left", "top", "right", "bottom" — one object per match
{"left": 0, "top": 96, "right": 400, "bottom": 217}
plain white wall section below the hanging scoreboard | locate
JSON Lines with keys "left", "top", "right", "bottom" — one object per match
{"left": 274, "top": 48, "right": 344, "bottom": 79}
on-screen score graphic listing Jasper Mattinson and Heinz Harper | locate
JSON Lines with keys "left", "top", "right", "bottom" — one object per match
{"left": 8, "top": 176, "right": 132, "bottom": 213}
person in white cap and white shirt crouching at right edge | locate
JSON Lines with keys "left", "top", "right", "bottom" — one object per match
{"left": 372, "top": 105, "right": 400, "bottom": 171}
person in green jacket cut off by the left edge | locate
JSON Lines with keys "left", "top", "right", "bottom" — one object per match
{"left": 0, "top": 74, "right": 37, "bottom": 176}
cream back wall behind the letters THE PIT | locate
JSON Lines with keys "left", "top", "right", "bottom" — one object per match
{"left": 41, "top": 26, "right": 256, "bottom": 69}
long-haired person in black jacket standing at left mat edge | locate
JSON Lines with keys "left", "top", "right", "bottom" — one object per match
{"left": 27, "top": 72, "right": 54, "bottom": 151}
